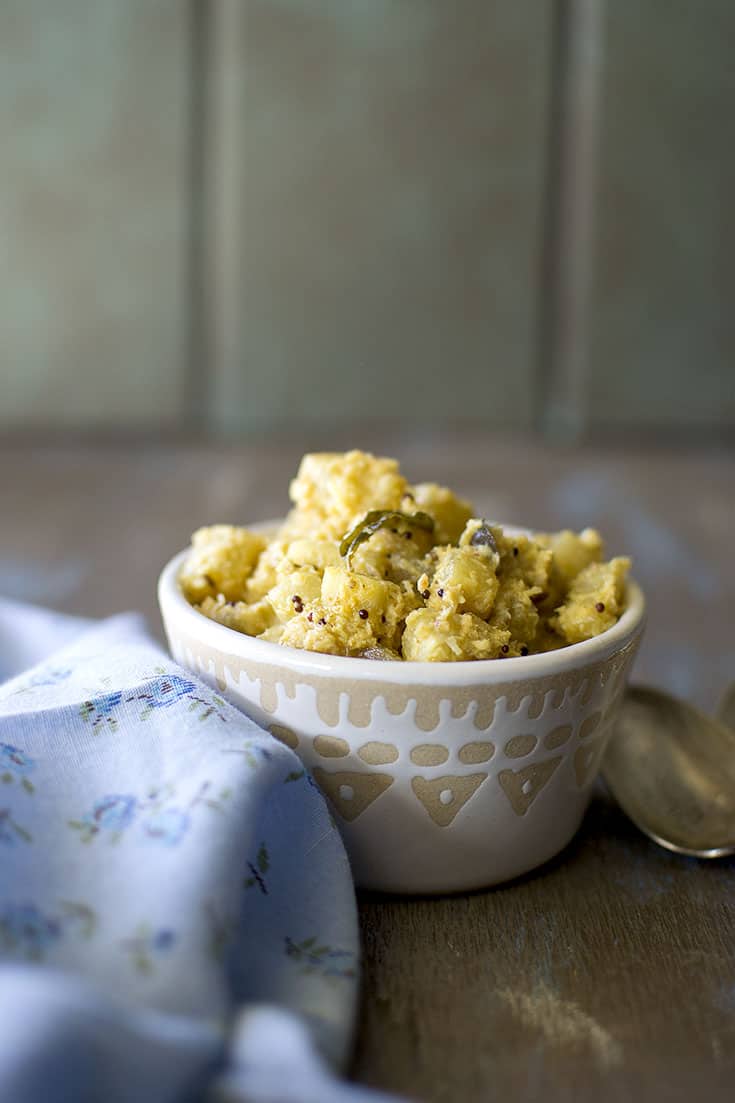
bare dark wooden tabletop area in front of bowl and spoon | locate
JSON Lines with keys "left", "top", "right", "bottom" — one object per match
{"left": 355, "top": 797, "right": 735, "bottom": 1103}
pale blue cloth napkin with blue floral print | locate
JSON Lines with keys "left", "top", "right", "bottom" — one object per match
{"left": 0, "top": 602, "right": 395, "bottom": 1103}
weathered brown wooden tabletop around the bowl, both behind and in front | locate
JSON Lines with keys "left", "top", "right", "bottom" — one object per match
{"left": 0, "top": 430, "right": 735, "bottom": 1103}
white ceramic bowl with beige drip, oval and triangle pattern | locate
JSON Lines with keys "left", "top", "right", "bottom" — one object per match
{"left": 159, "top": 526, "right": 645, "bottom": 893}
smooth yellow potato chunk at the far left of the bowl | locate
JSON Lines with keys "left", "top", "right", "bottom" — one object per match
{"left": 179, "top": 525, "right": 266, "bottom": 604}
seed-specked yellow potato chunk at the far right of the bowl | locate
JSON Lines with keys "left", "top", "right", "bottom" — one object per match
{"left": 552, "top": 557, "right": 630, "bottom": 643}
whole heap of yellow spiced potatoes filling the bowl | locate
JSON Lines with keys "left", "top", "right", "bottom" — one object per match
{"left": 181, "top": 451, "right": 629, "bottom": 662}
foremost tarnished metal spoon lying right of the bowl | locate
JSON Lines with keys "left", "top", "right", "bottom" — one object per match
{"left": 603, "top": 686, "right": 735, "bottom": 858}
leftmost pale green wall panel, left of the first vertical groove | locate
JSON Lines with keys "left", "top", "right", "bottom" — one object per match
{"left": 0, "top": 0, "right": 192, "bottom": 427}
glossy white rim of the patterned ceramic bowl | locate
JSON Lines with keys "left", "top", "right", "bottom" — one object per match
{"left": 158, "top": 522, "right": 646, "bottom": 686}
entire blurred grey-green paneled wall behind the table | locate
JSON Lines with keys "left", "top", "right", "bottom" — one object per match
{"left": 0, "top": 0, "right": 735, "bottom": 432}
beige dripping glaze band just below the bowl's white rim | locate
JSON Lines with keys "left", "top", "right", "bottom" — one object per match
{"left": 178, "top": 635, "right": 640, "bottom": 732}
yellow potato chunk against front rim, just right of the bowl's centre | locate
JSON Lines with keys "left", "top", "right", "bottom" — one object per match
{"left": 402, "top": 609, "right": 510, "bottom": 663}
